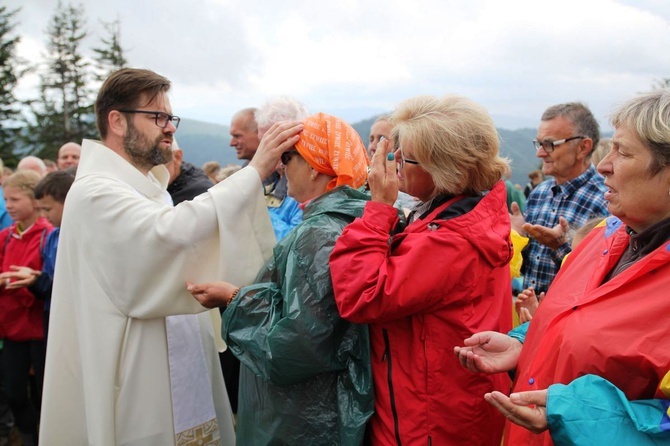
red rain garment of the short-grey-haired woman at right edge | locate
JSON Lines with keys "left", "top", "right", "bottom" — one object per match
{"left": 505, "top": 217, "right": 670, "bottom": 446}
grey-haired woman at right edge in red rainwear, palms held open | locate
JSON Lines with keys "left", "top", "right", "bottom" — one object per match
{"left": 454, "top": 89, "right": 670, "bottom": 446}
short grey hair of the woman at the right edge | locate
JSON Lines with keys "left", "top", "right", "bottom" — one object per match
{"left": 610, "top": 88, "right": 670, "bottom": 176}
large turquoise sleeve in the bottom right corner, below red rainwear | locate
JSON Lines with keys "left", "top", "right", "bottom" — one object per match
{"left": 547, "top": 375, "right": 670, "bottom": 446}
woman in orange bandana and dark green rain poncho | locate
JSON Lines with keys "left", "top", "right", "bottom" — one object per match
{"left": 190, "top": 113, "right": 373, "bottom": 445}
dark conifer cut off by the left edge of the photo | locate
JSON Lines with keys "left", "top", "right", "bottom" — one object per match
{"left": 0, "top": 6, "right": 23, "bottom": 164}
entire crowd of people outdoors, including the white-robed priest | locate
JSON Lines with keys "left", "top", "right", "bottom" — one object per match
{"left": 0, "top": 69, "right": 670, "bottom": 446}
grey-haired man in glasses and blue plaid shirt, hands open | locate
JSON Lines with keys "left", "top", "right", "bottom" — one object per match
{"left": 512, "top": 102, "right": 609, "bottom": 295}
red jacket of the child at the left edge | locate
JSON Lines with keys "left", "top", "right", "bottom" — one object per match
{"left": 0, "top": 218, "right": 52, "bottom": 341}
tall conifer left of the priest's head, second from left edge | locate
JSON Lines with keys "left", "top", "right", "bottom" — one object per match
{"left": 27, "top": 1, "right": 96, "bottom": 159}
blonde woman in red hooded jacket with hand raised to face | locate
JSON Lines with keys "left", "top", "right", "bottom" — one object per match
{"left": 330, "top": 96, "right": 512, "bottom": 446}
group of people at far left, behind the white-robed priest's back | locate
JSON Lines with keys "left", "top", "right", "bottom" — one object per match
{"left": 0, "top": 143, "right": 81, "bottom": 445}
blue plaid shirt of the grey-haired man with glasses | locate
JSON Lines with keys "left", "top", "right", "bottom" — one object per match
{"left": 524, "top": 165, "right": 609, "bottom": 293}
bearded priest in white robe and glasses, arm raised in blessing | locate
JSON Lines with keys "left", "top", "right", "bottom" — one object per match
{"left": 40, "top": 69, "right": 301, "bottom": 446}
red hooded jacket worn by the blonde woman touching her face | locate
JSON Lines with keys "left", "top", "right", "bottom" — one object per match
{"left": 330, "top": 182, "right": 512, "bottom": 446}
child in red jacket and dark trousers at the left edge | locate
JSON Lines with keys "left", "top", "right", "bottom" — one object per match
{"left": 0, "top": 171, "right": 51, "bottom": 446}
